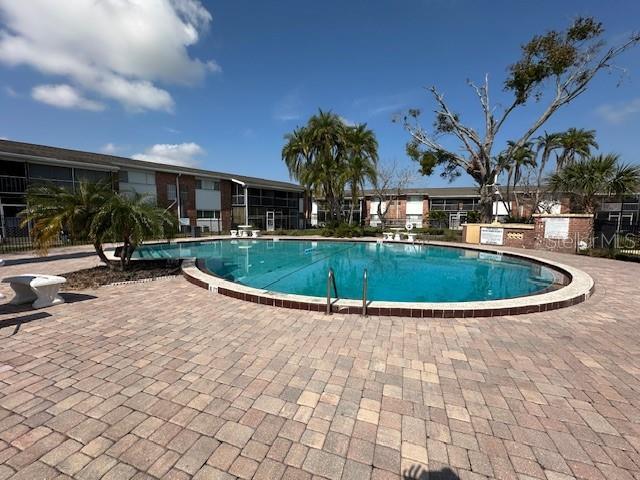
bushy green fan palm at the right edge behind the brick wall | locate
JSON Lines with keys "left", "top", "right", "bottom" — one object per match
{"left": 549, "top": 154, "right": 640, "bottom": 214}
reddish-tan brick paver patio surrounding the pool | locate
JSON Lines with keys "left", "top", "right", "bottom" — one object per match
{"left": 0, "top": 246, "right": 640, "bottom": 480}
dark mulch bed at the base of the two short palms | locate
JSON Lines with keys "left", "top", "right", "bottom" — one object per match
{"left": 62, "top": 260, "right": 180, "bottom": 290}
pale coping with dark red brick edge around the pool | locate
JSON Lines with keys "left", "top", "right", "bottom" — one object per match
{"left": 168, "top": 236, "right": 595, "bottom": 318}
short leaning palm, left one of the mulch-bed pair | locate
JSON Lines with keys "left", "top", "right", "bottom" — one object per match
{"left": 19, "top": 182, "right": 113, "bottom": 265}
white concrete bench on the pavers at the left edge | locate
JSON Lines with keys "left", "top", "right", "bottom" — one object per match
{"left": 2, "top": 274, "right": 67, "bottom": 308}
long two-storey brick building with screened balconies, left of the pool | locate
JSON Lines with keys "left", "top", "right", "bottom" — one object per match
{"left": 0, "top": 140, "right": 307, "bottom": 237}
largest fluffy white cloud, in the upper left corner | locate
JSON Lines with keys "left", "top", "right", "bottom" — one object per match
{"left": 0, "top": 0, "right": 220, "bottom": 111}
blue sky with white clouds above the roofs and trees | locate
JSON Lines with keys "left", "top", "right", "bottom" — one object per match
{"left": 0, "top": 0, "right": 640, "bottom": 186}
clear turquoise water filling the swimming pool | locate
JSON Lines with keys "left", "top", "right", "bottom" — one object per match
{"left": 134, "top": 240, "right": 558, "bottom": 302}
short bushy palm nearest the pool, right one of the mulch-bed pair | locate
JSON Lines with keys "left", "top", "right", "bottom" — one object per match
{"left": 90, "top": 193, "right": 178, "bottom": 270}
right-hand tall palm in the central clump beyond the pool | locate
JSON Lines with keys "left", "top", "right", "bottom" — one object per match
{"left": 343, "top": 124, "right": 378, "bottom": 225}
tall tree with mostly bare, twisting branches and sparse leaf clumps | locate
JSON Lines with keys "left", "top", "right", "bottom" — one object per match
{"left": 397, "top": 17, "right": 640, "bottom": 221}
